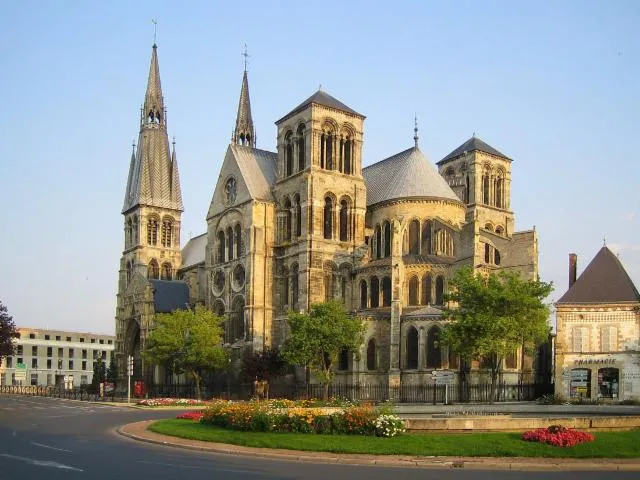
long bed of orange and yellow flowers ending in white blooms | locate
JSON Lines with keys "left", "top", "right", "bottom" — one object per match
{"left": 201, "top": 400, "right": 404, "bottom": 437}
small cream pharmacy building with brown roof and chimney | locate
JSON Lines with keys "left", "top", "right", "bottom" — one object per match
{"left": 555, "top": 246, "right": 640, "bottom": 401}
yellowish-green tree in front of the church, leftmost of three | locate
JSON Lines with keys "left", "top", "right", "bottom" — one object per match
{"left": 142, "top": 305, "right": 228, "bottom": 398}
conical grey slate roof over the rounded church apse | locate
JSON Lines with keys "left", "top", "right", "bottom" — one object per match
{"left": 362, "top": 147, "right": 460, "bottom": 206}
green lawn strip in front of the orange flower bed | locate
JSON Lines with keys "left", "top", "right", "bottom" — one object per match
{"left": 149, "top": 419, "right": 640, "bottom": 458}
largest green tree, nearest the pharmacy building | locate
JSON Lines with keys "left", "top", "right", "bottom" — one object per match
{"left": 442, "top": 267, "right": 553, "bottom": 401}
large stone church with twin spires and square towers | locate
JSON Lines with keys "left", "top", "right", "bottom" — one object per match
{"left": 116, "top": 45, "right": 538, "bottom": 386}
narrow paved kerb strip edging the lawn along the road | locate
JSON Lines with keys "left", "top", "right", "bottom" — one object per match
{"left": 117, "top": 420, "right": 640, "bottom": 471}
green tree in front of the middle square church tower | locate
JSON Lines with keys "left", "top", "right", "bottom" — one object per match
{"left": 282, "top": 300, "right": 366, "bottom": 399}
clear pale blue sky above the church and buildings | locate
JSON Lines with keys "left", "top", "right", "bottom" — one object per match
{"left": 0, "top": 0, "right": 640, "bottom": 334}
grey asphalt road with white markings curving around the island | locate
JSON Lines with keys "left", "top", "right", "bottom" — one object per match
{"left": 0, "top": 395, "right": 638, "bottom": 480}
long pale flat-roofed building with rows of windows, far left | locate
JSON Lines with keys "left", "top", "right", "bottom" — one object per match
{"left": 0, "top": 328, "right": 115, "bottom": 387}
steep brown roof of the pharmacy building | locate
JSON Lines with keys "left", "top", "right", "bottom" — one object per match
{"left": 557, "top": 247, "right": 640, "bottom": 304}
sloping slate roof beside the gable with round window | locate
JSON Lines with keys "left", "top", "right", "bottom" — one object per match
{"left": 230, "top": 144, "right": 278, "bottom": 200}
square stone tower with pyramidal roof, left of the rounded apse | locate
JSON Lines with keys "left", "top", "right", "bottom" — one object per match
{"left": 273, "top": 90, "right": 366, "bottom": 315}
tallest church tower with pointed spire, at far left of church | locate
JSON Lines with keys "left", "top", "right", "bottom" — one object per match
{"left": 116, "top": 44, "right": 183, "bottom": 382}
